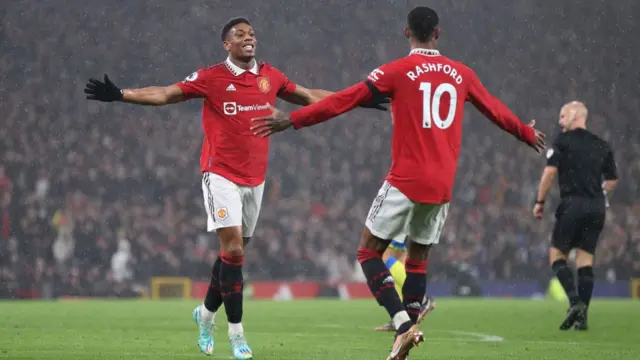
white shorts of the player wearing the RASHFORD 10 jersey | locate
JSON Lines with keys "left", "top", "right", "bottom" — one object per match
{"left": 365, "top": 181, "right": 449, "bottom": 245}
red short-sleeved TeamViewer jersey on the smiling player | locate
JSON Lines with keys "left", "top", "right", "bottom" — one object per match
{"left": 177, "top": 59, "right": 296, "bottom": 186}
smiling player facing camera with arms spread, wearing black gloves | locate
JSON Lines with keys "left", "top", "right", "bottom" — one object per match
{"left": 84, "top": 18, "right": 385, "bottom": 359}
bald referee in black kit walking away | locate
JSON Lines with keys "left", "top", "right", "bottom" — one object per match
{"left": 533, "top": 101, "right": 618, "bottom": 330}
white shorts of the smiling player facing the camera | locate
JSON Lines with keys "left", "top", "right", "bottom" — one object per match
{"left": 202, "top": 172, "right": 264, "bottom": 237}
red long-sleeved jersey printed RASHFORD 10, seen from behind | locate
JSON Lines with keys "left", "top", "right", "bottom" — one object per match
{"left": 291, "top": 49, "right": 536, "bottom": 204}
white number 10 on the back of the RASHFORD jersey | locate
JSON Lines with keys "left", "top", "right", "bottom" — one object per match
{"left": 420, "top": 82, "right": 458, "bottom": 129}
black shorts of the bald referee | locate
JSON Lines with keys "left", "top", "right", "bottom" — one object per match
{"left": 551, "top": 198, "right": 605, "bottom": 254}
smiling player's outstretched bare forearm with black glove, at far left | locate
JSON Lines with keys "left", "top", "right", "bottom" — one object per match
{"left": 84, "top": 74, "right": 186, "bottom": 106}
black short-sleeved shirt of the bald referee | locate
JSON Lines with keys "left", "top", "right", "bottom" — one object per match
{"left": 547, "top": 129, "right": 618, "bottom": 198}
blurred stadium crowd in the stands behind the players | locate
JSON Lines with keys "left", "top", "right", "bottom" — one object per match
{"left": 0, "top": 0, "right": 640, "bottom": 297}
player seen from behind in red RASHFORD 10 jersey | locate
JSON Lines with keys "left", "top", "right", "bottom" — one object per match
{"left": 252, "top": 7, "right": 544, "bottom": 359}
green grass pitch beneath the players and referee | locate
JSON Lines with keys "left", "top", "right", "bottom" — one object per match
{"left": 0, "top": 299, "right": 640, "bottom": 360}
